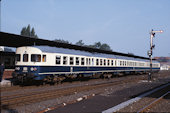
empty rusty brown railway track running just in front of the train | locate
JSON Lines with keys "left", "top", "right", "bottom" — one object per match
{"left": 1, "top": 77, "right": 139, "bottom": 109}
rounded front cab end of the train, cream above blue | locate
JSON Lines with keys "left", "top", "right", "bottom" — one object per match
{"left": 13, "top": 47, "right": 44, "bottom": 83}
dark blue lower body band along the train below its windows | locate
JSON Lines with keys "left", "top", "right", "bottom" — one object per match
{"left": 15, "top": 66, "right": 160, "bottom": 80}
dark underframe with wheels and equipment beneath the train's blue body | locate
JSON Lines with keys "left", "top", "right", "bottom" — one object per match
{"left": 12, "top": 70, "right": 159, "bottom": 85}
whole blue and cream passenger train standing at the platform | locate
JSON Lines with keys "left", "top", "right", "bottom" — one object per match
{"left": 13, "top": 46, "right": 160, "bottom": 82}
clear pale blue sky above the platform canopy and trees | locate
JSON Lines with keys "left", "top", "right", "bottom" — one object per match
{"left": 1, "top": 0, "right": 170, "bottom": 57}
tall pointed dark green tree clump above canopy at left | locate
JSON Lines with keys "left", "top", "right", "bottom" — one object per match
{"left": 20, "top": 24, "right": 38, "bottom": 38}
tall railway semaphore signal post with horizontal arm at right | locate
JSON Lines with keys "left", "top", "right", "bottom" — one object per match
{"left": 148, "top": 29, "right": 163, "bottom": 81}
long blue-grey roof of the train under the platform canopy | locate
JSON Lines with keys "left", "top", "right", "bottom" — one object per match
{"left": 33, "top": 46, "right": 153, "bottom": 61}
